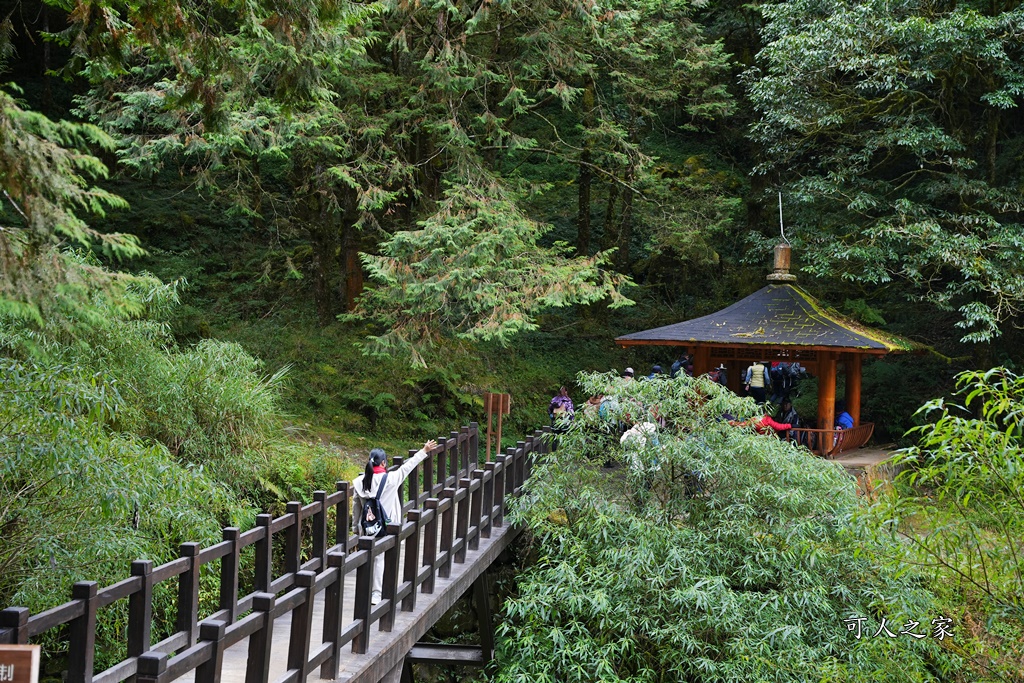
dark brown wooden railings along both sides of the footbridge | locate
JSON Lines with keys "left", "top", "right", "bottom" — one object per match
{"left": 0, "top": 422, "right": 550, "bottom": 683}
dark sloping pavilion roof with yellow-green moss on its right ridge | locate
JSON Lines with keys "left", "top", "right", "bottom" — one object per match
{"left": 615, "top": 283, "right": 918, "bottom": 353}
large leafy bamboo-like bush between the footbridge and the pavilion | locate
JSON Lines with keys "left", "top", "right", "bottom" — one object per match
{"left": 497, "top": 375, "right": 958, "bottom": 681}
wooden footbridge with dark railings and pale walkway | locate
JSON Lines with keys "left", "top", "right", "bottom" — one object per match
{"left": 0, "top": 423, "right": 550, "bottom": 683}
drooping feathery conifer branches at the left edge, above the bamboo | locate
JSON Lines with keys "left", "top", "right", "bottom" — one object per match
{"left": 0, "top": 87, "right": 144, "bottom": 322}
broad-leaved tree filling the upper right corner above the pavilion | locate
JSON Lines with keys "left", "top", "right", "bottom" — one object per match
{"left": 746, "top": 0, "right": 1024, "bottom": 342}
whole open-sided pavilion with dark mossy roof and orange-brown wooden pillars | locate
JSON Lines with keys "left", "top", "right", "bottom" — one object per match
{"left": 615, "top": 245, "right": 921, "bottom": 456}
